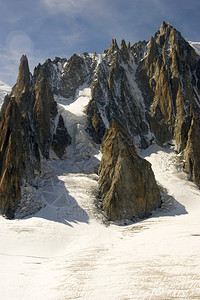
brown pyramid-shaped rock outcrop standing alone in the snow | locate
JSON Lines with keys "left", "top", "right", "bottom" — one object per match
{"left": 99, "top": 122, "right": 161, "bottom": 221}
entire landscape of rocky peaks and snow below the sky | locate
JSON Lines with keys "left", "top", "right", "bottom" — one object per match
{"left": 0, "top": 22, "right": 200, "bottom": 300}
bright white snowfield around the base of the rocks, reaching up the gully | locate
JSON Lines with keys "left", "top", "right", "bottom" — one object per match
{"left": 0, "top": 87, "right": 200, "bottom": 300}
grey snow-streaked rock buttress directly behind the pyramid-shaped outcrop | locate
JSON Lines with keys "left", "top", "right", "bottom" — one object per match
{"left": 87, "top": 40, "right": 149, "bottom": 147}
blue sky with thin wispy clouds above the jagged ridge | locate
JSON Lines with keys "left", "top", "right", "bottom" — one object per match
{"left": 0, "top": 0, "right": 200, "bottom": 86}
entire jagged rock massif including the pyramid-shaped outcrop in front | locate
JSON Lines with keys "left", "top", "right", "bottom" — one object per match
{"left": 0, "top": 22, "right": 200, "bottom": 220}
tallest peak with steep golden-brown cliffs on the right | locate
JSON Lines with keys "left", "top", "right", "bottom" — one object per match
{"left": 136, "top": 22, "right": 200, "bottom": 184}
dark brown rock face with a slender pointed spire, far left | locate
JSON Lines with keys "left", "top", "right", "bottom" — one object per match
{"left": 0, "top": 56, "right": 70, "bottom": 217}
